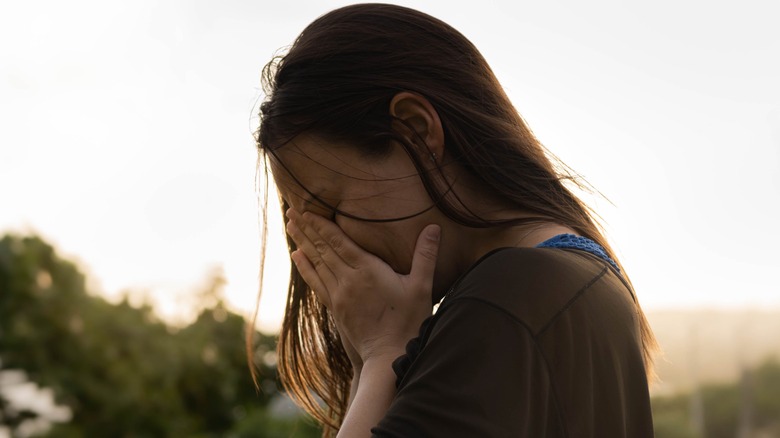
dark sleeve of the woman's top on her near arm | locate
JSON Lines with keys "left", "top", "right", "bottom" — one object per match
{"left": 372, "top": 298, "right": 561, "bottom": 437}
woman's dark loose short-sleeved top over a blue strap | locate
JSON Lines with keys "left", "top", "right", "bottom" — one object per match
{"left": 372, "top": 248, "right": 653, "bottom": 438}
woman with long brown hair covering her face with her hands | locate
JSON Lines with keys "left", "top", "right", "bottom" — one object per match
{"left": 257, "top": 4, "right": 654, "bottom": 437}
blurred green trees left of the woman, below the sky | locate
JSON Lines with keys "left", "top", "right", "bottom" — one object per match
{"left": 0, "top": 235, "right": 316, "bottom": 437}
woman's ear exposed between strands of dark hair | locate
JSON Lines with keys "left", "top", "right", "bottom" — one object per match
{"left": 390, "top": 91, "right": 444, "bottom": 161}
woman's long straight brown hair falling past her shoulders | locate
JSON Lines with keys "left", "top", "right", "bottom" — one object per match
{"left": 257, "top": 4, "right": 655, "bottom": 435}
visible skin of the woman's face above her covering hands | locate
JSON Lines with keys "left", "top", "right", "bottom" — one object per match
{"left": 269, "top": 135, "right": 442, "bottom": 274}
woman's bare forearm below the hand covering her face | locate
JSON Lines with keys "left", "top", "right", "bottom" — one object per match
{"left": 338, "top": 353, "right": 400, "bottom": 438}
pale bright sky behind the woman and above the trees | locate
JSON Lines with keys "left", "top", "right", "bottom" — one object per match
{"left": 0, "top": 0, "right": 780, "bottom": 331}
